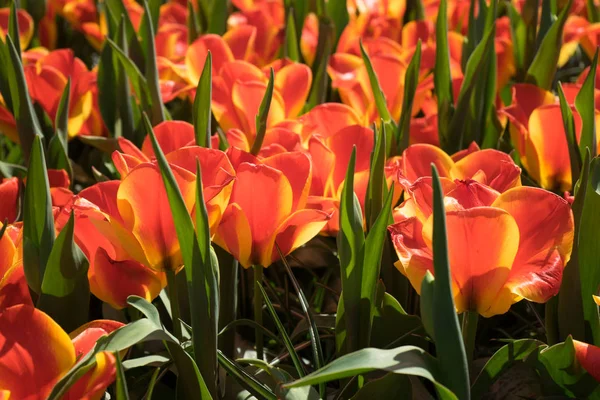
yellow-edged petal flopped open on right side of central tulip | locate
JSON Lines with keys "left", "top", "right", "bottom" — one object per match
{"left": 263, "top": 209, "right": 333, "bottom": 265}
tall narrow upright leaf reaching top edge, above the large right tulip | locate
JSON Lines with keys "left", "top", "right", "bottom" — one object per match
{"left": 433, "top": 0, "right": 454, "bottom": 147}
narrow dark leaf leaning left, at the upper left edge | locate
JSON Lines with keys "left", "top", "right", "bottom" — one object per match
{"left": 3, "top": 36, "right": 42, "bottom": 160}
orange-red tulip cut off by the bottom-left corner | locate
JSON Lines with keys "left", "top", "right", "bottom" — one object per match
{"left": 0, "top": 305, "right": 123, "bottom": 400}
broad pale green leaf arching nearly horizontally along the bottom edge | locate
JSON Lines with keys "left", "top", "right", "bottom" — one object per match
{"left": 284, "top": 346, "right": 458, "bottom": 399}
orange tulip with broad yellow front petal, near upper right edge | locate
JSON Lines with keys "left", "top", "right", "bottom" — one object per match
{"left": 501, "top": 84, "right": 600, "bottom": 191}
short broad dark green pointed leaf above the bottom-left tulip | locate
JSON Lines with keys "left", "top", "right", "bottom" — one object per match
{"left": 37, "top": 212, "right": 90, "bottom": 332}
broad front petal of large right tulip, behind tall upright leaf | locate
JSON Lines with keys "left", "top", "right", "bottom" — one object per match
{"left": 423, "top": 207, "right": 520, "bottom": 317}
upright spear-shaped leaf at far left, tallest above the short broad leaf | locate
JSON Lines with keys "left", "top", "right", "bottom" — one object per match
{"left": 23, "top": 135, "right": 54, "bottom": 294}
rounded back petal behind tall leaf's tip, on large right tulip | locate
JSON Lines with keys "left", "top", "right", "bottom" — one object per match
{"left": 402, "top": 144, "right": 454, "bottom": 182}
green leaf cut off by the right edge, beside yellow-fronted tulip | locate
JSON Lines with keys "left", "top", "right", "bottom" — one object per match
{"left": 575, "top": 48, "right": 598, "bottom": 158}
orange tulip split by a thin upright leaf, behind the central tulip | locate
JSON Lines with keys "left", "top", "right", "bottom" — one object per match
{"left": 212, "top": 57, "right": 312, "bottom": 142}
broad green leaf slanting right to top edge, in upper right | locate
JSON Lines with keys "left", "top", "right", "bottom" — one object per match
{"left": 525, "top": 0, "right": 573, "bottom": 90}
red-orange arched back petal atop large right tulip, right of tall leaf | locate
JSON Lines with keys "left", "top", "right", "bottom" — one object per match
{"left": 450, "top": 149, "right": 521, "bottom": 192}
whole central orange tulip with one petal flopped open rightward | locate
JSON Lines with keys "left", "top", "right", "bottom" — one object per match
{"left": 215, "top": 148, "right": 331, "bottom": 268}
